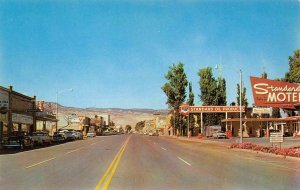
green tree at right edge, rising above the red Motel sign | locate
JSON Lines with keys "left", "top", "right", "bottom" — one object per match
{"left": 285, "top": 49, "right": 300, "bottom": 83}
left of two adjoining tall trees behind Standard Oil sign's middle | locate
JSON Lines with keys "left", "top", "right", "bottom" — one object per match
{"left": 198, "top": 67, "right": 218, "bottom": 126}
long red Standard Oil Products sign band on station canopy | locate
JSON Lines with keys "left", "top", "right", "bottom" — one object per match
{"left": 179, "top": 104, "right": 245, "bottom": 115}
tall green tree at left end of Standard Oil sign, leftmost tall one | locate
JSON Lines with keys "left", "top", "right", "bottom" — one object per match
{"left": 162, "top": 62, "right": 188, "bottom": 134}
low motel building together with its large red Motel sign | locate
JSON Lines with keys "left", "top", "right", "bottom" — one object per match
{"left": 222, "top": 77, "right": 300, "bottom": 137}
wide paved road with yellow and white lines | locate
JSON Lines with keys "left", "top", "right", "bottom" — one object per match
{"left": 0, "top": 134, "right": 300, "bottom": 190}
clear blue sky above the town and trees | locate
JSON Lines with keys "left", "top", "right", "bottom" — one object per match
{"left": 0, "top": 0, "right": 300, "bottom": 109}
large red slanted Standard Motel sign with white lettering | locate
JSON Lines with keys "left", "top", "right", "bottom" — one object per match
{"left": 250, "top": 77, "right": 300, "bottom": 109}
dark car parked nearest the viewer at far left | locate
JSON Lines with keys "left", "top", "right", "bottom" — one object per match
{"left": 2, "top": 131, "right": 33, "bottom": 149}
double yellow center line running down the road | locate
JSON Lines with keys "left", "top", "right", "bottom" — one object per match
{"left": 95, "top": 136, "right": 131, "bottom": 190}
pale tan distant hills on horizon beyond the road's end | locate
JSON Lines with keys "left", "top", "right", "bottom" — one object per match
{"left": 44, "top": 102, "right": 168, "bottom": 128}
